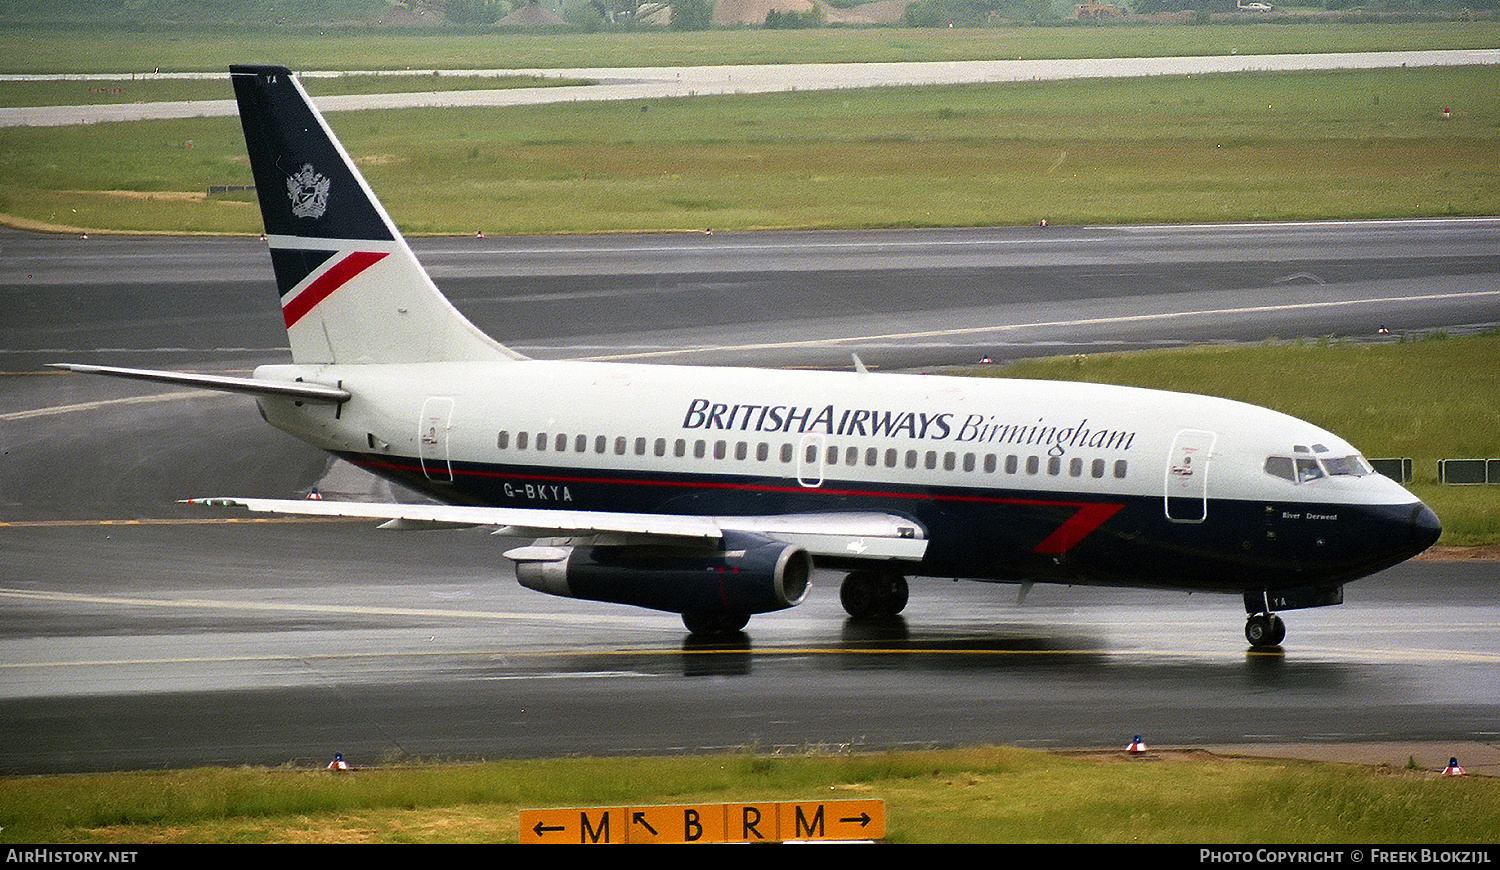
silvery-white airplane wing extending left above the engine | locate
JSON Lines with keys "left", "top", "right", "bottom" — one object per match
{"left": 188, "top": 498, "right": 927, "bottom": 561}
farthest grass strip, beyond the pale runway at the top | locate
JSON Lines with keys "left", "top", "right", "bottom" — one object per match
{"left": 0, "top": 21, "right": 1500, "bottom": 74}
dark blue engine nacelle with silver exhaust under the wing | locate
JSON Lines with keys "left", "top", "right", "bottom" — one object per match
{"left": 506, "top": 533, "right": 813, "bottom": 615}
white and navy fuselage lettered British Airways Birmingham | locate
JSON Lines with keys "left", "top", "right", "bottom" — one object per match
{"left": 257, "top": 360, "right": 1437, "bottom": 591}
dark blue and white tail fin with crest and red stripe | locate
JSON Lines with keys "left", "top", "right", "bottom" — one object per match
{"left": 230, "top": 66, "right": 524, "bottom": 365}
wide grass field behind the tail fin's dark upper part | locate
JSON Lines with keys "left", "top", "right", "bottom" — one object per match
{"left": 0, "top": 68, "right": 1500, "bottom": 233}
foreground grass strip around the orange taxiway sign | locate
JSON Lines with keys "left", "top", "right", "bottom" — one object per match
{"left": 0, "top": 747, "right": 1500, "bottom": 843}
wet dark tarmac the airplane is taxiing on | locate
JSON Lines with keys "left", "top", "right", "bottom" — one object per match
{"left": 0, "top": 221, "right": 1500, "bottom": 773}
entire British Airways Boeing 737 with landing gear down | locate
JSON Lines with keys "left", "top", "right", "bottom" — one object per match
{"left": 62, "top": 66, "right": 1440, "bottom": 647}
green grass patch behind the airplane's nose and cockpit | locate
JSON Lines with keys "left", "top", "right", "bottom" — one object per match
{"left": 971, "top": 335, "right": 1500, "bottom": 546}
